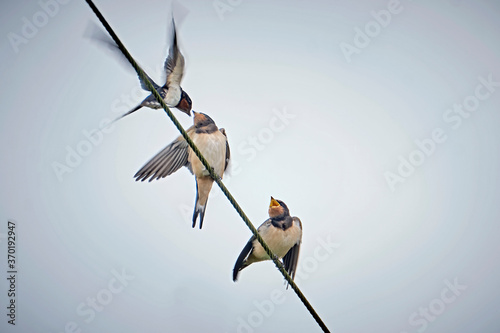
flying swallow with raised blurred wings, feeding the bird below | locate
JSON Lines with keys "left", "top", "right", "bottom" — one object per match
{"left": 92, "top": 18, "right": 193, "bottom": 120}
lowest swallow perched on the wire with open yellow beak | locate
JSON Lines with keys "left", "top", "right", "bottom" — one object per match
{"left": 233, "top": 197, "right": 302, "bottom": 288}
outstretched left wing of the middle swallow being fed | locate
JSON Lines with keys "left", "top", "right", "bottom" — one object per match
{"left": 134, "top": 126, "right": 194, "bottom": 181}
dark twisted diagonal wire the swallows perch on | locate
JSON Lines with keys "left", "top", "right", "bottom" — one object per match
{"left": 85, "top": 0, "right": 330, "bottom": 332}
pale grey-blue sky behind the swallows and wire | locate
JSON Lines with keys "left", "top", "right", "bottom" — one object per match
{"left": 0, "top": 0, "right": 500, "bottom": 333}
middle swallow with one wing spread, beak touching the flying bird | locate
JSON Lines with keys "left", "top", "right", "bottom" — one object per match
{"left": 134, "top": 111, "right": 230, "bottom": 229}
